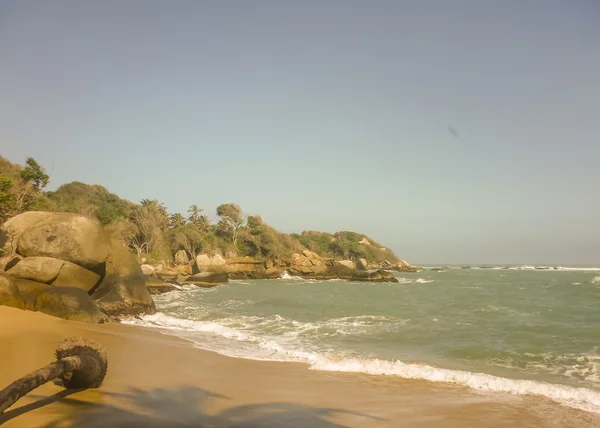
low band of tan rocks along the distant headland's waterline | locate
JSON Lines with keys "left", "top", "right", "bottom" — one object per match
{"left": 142, "top": 250, "right": 418, "bottom": 294}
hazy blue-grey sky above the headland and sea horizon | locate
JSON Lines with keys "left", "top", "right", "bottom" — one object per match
{"left": 0, "top": 0, "right": 600, "bottom": 264}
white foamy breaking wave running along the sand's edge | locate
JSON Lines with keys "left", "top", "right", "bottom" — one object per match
{"left": 123, "top": 313, "right": 600, "bottom": 413}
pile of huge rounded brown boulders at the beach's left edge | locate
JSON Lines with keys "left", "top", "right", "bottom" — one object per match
{"left": 0, "top": 211, "right": 156, "bottom": 323}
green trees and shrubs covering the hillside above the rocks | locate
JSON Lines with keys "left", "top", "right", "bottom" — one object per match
{"left": 0, "top": 157, "right": 398, "bottom": 263}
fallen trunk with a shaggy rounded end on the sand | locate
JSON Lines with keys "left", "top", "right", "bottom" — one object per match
{"left": 0, "top": 337, "right": 108, "bottom": 415}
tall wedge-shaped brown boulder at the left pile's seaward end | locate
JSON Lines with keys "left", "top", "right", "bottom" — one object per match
{"left": 92, "top": 239, "right": 156, "bottom": 315}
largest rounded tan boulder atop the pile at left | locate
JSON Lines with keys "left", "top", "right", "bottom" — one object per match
{"left": 3, "top": 211, "right": 110, "bottom": 273}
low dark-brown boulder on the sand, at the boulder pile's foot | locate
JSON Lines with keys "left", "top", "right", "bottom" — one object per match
{"left": 35, "top": 287, "right": 107, "bottom": 324}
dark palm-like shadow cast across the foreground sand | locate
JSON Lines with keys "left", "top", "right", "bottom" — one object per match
{"left": 0, "top": 386, "right": 381, "bottom": 428}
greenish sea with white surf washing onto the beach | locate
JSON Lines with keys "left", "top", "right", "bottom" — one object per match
{"left": 124, "top": 266, "right": 600, "bottom": 413}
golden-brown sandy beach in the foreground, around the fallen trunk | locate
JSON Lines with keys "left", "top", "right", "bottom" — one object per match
{"left": 0, "top": 307, "right": 600, "bottom": 428}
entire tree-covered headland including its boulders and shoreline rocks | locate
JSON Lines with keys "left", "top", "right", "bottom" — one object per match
{"left": 0, "top": 157, "right": 418, "bottom": 323}
